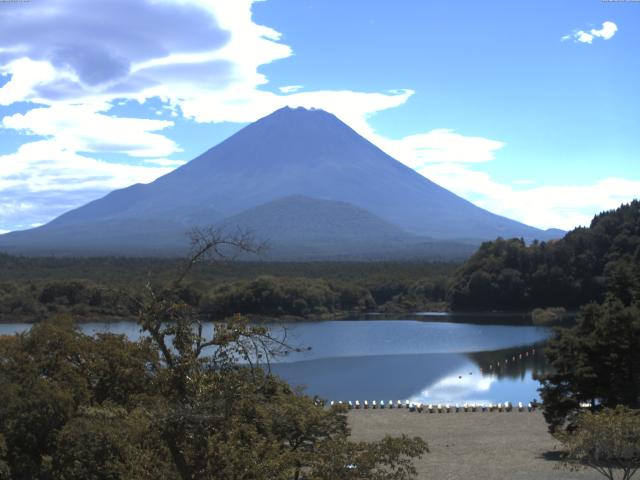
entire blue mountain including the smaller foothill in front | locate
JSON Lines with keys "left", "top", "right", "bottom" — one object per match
{"left": 0, "top": 107, "right": 560, "bottom": 257}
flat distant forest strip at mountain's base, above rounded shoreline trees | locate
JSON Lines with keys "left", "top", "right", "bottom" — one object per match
{"left": 0, "top": 252, "right": 459, "bottom": 287}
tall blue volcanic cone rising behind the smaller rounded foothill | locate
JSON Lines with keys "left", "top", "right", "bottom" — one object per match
{"left": 0, "top": 104, "right": 560, "bottom": 253}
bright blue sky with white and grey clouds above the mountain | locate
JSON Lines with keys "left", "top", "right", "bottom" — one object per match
{"left": 0, "top": 0, "right": 640, "bottom": 231}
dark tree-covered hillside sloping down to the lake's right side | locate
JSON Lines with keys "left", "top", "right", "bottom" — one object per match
{"left": 448, "top": 200, "right": 640, "bottom": 310}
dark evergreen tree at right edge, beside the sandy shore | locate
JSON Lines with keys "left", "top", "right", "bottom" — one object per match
{"left": 540, "top": 297, "right": 640, "bottom": 432}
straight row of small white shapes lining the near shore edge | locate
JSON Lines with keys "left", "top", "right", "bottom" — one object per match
{"left": 340, "top": 400, "right": 536, "bottom": 413}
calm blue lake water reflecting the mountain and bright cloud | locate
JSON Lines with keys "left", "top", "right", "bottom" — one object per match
{"left": 0, "top": 316, "right": 550, "bottom": 403}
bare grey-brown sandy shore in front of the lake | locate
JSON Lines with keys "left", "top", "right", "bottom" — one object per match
{"left": 349, "top": 409, "right": 603, "bottom": 480}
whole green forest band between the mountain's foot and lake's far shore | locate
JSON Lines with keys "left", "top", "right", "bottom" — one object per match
{"left": 0, "top": 255, "right": 454, "bottom": 321}
